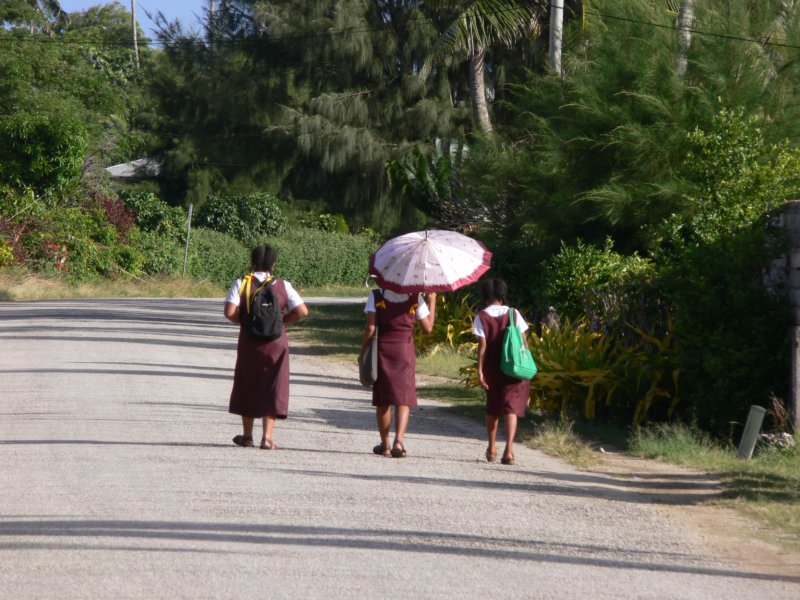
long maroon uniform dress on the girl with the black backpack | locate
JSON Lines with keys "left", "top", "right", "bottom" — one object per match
{"left": 228, "top": 279, "right": 289, "bottom": 419}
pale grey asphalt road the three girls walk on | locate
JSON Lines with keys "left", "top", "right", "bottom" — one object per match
{"left": 0, "top": 299, "right": 800, "bottom": 600}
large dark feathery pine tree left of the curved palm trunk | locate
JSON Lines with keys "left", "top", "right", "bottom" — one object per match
{"left": 148, "top": 0, "right": 468, "bottom": 227}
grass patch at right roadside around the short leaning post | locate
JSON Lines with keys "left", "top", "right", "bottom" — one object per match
{"left": 630, "top": 425, "right": 800, "bottom": 549}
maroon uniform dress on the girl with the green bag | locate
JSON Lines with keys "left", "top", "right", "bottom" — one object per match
{"left": 480, "top": 309, "right": 531, "bottom": 417}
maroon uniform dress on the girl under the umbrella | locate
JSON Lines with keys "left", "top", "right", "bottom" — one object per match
{"left": 372, "top": 294, "right": 417, "bottom": 408}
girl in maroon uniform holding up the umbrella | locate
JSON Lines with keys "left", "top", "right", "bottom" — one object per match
{"left": 360, "top": 290, "right": 436, "bottom": 458}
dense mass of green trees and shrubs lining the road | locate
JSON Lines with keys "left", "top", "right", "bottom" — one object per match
{"left": 0, "top": 0, "right": 800, "bottom": 438}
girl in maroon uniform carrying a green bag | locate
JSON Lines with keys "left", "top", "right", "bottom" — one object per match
{"left": 472, "top": 279, "right": 531, "bottom": 465}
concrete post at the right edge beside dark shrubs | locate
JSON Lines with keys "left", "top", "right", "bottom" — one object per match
{"left": 781, "top": 200, "right": 800, "bottom": 432}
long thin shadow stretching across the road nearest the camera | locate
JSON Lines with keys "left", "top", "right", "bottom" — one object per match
{"left": 0, "top": 519, "right": 800, "bottom": 583}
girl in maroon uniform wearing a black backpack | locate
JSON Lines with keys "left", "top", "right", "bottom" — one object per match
{"left": 225, "top": 246, "right": 308, "bottom": 450}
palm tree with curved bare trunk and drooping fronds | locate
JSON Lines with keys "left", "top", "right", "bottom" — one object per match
{"left": 420, "top": 0, "right": 549, "bottom": 135}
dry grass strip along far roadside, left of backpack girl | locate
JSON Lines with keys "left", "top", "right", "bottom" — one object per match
{"left": 0, "top": 271, "right": 225, "bottom": 301}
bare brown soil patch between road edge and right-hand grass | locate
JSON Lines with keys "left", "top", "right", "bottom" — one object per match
{"left": 589, "top": 451, "right": 800, "bottom": 577}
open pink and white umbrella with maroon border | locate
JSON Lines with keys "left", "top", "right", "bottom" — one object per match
{"left": 369, "top": 229, "right": 492, "bottom": 293}
